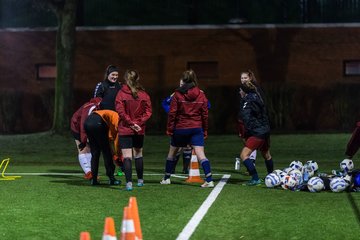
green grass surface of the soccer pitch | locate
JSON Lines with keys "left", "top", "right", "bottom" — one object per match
{"left": 0, "top": 133, "right": 360, "bottom": 240}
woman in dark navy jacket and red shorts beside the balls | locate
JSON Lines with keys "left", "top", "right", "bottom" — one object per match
{"left": 239, "top": 81, "right": 274, "bottom": 186}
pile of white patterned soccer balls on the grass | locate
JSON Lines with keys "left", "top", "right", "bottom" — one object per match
{"left": 265, "top": 159, "right": 360, "bottom": 192}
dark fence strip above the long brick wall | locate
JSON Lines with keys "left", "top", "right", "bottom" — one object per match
{"left": 0, "top": 0, "right": 360, "bottom": 28}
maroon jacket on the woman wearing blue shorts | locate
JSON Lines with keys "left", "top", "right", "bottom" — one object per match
{"left": 167, "top": 87, "right": 208, "bottom": 133}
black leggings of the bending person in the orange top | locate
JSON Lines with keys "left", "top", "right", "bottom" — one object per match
{"left": 84, "top": 113, "right": 115, "bottom": 179}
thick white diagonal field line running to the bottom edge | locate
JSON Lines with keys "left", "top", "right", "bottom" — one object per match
{"left": 176, "top": 174, "right": 231, "bottom": 240}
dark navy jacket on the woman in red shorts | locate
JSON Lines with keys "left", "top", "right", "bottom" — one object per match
{"left": 239, "top": 92, "right": 270, "bottom": 138}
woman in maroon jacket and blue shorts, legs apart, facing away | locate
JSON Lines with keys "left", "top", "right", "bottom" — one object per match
{"left": 160, "top": 70, "right": 214, "bottom": 187}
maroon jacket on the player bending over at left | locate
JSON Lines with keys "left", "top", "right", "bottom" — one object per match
{"left": 70, "top": 97, "right": 101, "bottom": 143}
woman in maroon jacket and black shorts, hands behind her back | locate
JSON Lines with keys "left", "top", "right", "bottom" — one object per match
{"left": 115, "top": 70, "right": 152, "bottom": 191}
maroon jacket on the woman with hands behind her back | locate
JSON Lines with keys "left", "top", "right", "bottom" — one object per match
{"left": 115, "top": 85, "right": 152, "bottom": 135}
